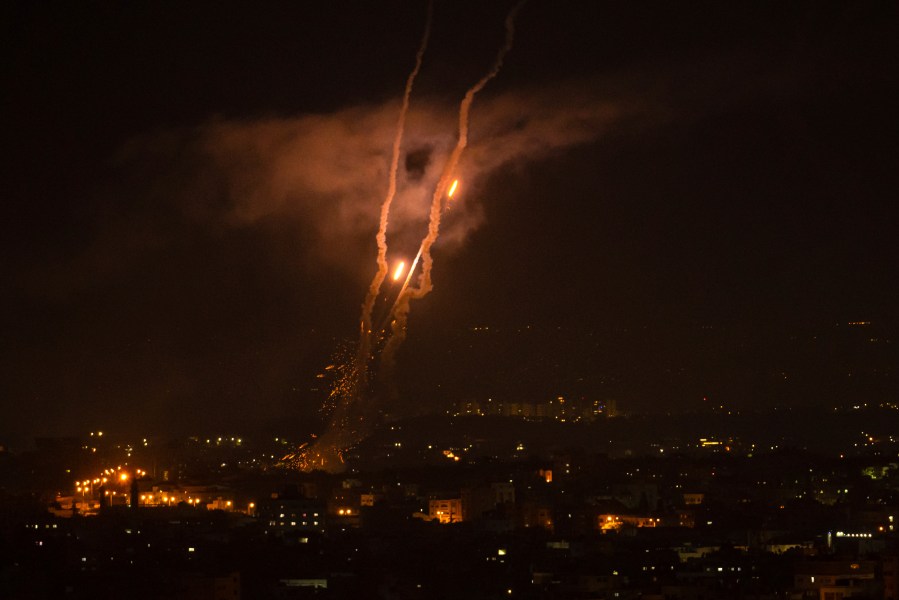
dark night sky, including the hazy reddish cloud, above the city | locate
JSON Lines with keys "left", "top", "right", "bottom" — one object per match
{"left": 0, "top": 0, "right": 899, "bottom": 441}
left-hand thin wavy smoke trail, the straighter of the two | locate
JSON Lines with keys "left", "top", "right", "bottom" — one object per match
{"left": 359, "top": 2, "right": 434, "bottom": 360}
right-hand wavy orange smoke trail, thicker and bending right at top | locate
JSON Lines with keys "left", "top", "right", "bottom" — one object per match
{"left": 381, "top": 0, "right": 525, "bottom": 384}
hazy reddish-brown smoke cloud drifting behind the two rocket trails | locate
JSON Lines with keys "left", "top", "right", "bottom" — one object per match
{"left": 103, "top": 90, "right": 622, "bottom": 288}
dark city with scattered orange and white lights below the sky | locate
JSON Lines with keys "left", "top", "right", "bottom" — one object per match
{"left": 0, "top": 403, "right": 899, "bottom": 599}
